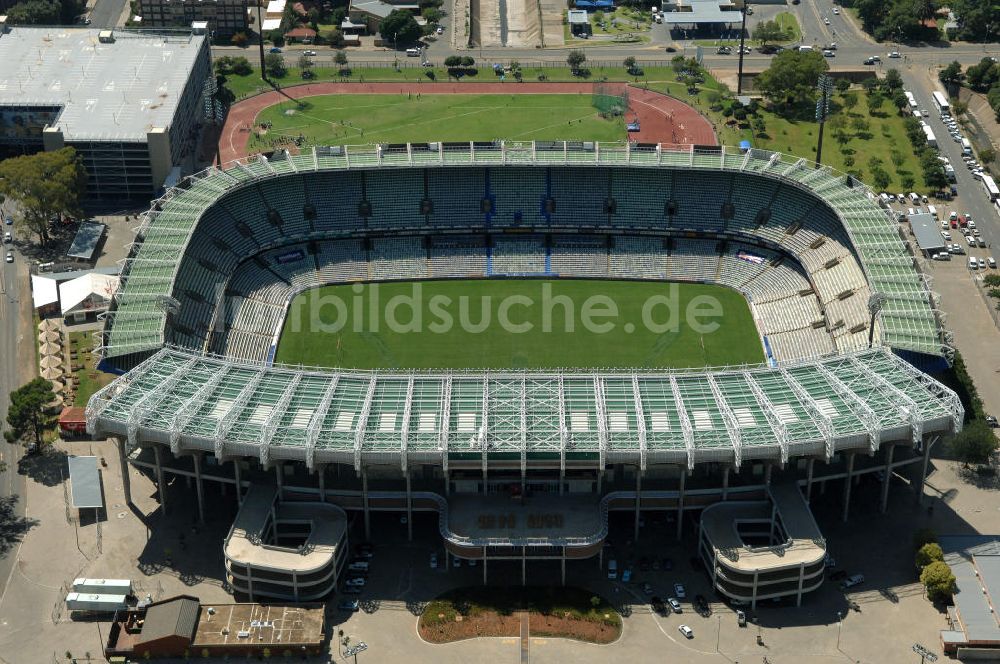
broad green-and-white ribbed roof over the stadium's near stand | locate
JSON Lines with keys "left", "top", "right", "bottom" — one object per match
{"left": 87, "top": 348, "right": 963, "bottom": 469}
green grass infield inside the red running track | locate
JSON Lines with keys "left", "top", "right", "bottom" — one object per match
{"left": 250, "top": 94, "right": 626, "bottom": 148}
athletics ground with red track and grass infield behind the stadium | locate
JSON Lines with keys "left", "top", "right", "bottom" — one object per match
{"left": 217, "top": 82, "right": 717, "bottom": 164}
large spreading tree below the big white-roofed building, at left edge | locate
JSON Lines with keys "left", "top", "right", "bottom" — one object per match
{"left": 0, "top": 148, "right": 87, "bottom": 245}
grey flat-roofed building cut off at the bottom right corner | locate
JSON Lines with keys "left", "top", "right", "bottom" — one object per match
{"left": 938, "top": 535, "right": 1000, "bottom": 648}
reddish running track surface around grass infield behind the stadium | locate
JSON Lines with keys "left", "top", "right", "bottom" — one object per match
{"left": 219, "top": 83, "right": 717, "bottom": 164}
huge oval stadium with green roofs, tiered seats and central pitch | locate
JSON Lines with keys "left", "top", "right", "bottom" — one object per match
{"left": 87, "top": 142, "right": 964, "bottom": 603}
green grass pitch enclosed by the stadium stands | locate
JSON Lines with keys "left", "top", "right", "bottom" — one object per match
{"left": 275, "top": 279, "right": 763, "bottom": 369}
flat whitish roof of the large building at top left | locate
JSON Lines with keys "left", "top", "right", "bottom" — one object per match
{"left": 0, "top": 26, "right": 206, "bottom": 141}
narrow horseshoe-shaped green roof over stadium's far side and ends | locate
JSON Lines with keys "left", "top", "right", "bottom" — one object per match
{"left": 101, "top": 142, "right": 948, "bottom": 357}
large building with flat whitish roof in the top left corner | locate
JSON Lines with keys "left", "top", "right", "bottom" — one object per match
{"left": 0, "top": 26, "right": 212, "bottom": 199}
